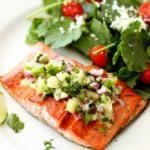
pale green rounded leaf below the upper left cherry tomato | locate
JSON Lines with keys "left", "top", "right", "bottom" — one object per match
{"left": 45, "top": 18, "right": 82, "bottom": 48}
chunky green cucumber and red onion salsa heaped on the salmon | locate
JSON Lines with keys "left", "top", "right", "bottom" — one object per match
{"left": 21, "top": 52, "right": 123, "bottom": 126}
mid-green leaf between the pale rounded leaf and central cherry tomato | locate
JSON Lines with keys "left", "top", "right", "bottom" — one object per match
{"left": 72, "top": 19, "right": 112, "bottom": 56}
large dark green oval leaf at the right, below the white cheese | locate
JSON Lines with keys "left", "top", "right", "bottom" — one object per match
{"left": 120, "top": 22, "right": 148, "bottom": 72}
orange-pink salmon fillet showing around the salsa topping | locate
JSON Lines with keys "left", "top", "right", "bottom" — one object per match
{"left": 0, "top": 43, "right": 147, "bottom": 150}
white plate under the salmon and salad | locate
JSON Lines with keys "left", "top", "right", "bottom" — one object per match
{"left": 0, "top": 0, "right": 150, "bottom": 150}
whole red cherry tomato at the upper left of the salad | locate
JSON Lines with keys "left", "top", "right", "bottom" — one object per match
{"left": 61, "top": 2, "right": 83, "bottom": 18}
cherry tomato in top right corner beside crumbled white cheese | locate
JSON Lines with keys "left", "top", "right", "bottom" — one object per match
{"left": 139, "top": 2, "right": 150, "bottom": 24}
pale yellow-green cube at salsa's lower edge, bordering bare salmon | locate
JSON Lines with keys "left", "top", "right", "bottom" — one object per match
{"left": 66, "top": 98, "right": 79, "bottom": 113}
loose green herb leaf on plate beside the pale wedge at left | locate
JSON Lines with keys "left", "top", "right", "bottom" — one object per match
{"left": 7, "top": 113, "right": 24, "bottom": 133}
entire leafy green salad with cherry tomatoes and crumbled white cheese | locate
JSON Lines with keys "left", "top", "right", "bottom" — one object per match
{"left": 26, "top": 0, "right": 150, "bottom": 99}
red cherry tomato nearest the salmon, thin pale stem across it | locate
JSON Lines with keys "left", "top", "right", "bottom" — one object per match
{"left": 89, "top": 45, "right": 107, "bottom": 67}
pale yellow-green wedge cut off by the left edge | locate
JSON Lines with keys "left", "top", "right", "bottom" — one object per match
{"left": 0, "top": 92, "right": 7, "bottom": 125}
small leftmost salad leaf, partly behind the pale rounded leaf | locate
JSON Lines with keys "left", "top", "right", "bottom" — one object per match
{"left": 26, "top": 19, "right": 43, "bottom": 44}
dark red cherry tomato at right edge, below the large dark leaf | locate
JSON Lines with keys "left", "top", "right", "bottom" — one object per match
{"left": 140, "top": 64, "right": 150, "bottom": 85}
